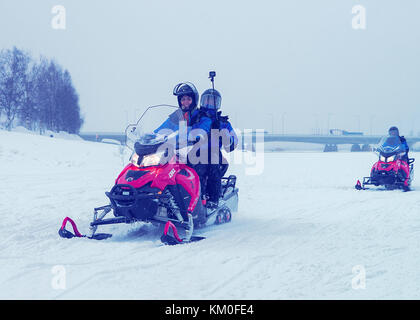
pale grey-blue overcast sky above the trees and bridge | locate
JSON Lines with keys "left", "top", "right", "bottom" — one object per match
{"left": 0, "top": 0, "right": 420, "bottom": 135}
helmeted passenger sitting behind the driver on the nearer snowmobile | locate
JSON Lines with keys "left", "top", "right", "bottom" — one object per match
{"left": 200, "top": 89, "right": 238, "bottom": 208}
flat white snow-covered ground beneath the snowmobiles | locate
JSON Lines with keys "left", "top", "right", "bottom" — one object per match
{"left": 0, "top": 131, "right": 420, "bottom": 299}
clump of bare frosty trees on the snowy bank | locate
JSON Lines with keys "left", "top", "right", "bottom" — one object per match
{"left": 0, "top": 47, "right": 83, "bottom": 133}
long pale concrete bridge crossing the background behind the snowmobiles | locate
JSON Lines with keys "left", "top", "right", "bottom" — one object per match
{"left": 79, "top": 132, "right": 420, "bottom": 152}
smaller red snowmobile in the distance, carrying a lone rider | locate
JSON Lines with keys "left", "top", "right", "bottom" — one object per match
{"left": 355, "top": 136, "right": 415, "bottom": 191}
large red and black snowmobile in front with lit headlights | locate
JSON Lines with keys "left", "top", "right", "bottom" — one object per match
{"left": 59, "top": 105, "right": 238, "bottom": 245}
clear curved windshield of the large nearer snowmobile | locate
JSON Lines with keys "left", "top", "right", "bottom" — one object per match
{"left": 125, "top": 105, "right": 183, "bottom": 151}
